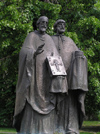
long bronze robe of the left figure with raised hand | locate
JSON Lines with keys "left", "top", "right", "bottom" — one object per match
{"left": 13, "top": 31, "right": 62, "bottom": 134}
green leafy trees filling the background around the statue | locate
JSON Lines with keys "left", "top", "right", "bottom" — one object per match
{"left": 0, "top": 0, "right": 100, "bottom": 126}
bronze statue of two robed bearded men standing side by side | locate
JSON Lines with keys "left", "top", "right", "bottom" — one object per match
{"left": 13, "top": 16, "right": 88, "bottom": 134}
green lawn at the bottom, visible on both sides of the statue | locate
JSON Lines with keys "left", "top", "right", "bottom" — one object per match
{"left": 0, "top": 121, "right": 100, "bottom": 134}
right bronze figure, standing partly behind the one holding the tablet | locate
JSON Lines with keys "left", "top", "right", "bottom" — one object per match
{"left": 52, "top": 19, "right": 88, "bottom": 134}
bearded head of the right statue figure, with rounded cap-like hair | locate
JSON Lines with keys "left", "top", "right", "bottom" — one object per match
{"left": 54, "top": 19, "right": 66, "bottom": 34}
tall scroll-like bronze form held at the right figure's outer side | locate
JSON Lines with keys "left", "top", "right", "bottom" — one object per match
{"left": 69, "top": 51, "right": 88, "bottom": 91}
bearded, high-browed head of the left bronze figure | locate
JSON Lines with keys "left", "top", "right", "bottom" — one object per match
{"left": 37, "top": 16, "right": 48, "bottom": 34}
